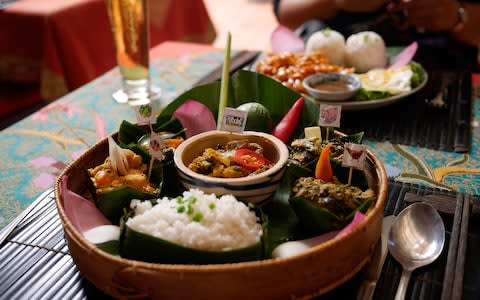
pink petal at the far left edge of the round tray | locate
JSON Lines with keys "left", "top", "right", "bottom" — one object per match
{"left": 61, "top": 176, "right": 112, "bottom": 233}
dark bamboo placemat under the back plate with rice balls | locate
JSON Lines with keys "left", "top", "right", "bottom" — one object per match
{"left": 341, "top": 71, "right": 473, "bottom": 152}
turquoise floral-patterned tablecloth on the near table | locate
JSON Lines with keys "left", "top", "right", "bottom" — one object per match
{"left": 0, "top": 42, "right": 480, "bottom": 229}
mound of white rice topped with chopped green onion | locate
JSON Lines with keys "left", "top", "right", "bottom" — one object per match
{"left": 126, "top": 189, "right": 262, "bottom": 251}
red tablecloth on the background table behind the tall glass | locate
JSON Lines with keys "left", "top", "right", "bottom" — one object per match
{"left": 0, "top": 0, "right": 215, "bottom": 116}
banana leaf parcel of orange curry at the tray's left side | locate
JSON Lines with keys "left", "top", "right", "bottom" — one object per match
{"left": 87, "top": 121, "right": 183, "bottom": 224}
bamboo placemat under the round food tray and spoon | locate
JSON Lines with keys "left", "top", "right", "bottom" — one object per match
{"left": 0, "top": 182, "right": 480, "bottom": 299}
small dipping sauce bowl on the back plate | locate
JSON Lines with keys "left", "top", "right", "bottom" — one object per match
{"left": 303, "top": 73, "right": 361, "bottom": 101}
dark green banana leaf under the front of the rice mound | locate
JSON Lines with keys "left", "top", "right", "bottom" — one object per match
{"left": 120, "top": 224, "right": 263, "bottom": 264}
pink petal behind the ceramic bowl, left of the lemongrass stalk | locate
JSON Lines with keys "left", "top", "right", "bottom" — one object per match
{"left": 172, "top": 100, "right": 217, "bottom": 138}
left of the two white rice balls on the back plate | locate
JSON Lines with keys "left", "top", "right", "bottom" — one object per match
{"left": 305, "top": 28, "right": 345, "bottom": 66}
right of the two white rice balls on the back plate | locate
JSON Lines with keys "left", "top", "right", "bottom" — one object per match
{"left": 345, "top": 31, "right": 387, "bottom": 73}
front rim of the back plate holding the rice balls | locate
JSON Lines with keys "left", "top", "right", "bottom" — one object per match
{"left": 307, "top": 72, "right": 428, "bottom": 110}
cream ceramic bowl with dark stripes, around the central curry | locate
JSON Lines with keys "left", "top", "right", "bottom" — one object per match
{"left": 174, "top": 130, "right": 288, "bottom": 203}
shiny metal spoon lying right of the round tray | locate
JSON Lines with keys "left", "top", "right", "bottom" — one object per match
{"left": 388, "top": 203, "right": 445, "bottom": 300}
